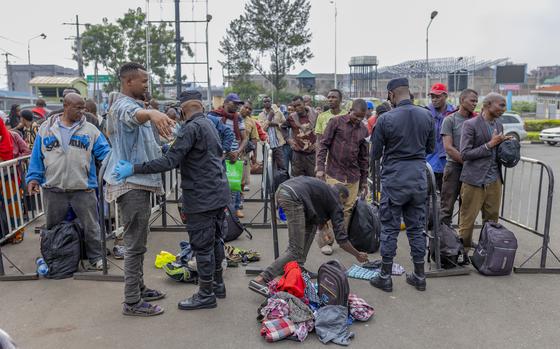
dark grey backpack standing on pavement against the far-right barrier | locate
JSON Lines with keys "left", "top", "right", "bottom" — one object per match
{"left": 471, "top": 222, "right": 517, "bottom": 276}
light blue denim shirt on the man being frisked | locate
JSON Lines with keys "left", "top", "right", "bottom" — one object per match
{"left": 103, "top": 93, "right": 162, "bottom": 187}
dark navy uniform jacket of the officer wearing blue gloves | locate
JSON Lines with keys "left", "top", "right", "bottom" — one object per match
{"left": 134, "top": 113, "right": 231, "bottom": 214}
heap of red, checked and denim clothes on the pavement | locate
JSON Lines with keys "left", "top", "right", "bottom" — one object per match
{"left": 257, "top": 261, "right": 374, "bottom": 345}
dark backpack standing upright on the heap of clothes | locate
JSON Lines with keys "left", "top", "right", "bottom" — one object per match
{"left": 317, "top": 260, "right": 350, "bottom": 307}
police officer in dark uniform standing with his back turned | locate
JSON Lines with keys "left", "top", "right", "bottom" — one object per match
{"left": 370, "top": 78, "right": 435, "bottom": 292}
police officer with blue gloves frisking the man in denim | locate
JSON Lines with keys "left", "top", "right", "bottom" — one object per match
{"left": 114, "top": 93, "right": 231, "bottom": 310}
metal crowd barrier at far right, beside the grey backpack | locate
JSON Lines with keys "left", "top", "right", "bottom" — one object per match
{"left": 500, "top": 157, "right": 560, "bottom": 274}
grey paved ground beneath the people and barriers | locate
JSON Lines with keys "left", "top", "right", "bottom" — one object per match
{"left": 0, "top": 145, "right": 560, "bottom": 349}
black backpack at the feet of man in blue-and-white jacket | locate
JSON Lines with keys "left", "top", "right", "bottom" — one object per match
{"left": 41, "top": 221, "right": 82, "bottom": 279}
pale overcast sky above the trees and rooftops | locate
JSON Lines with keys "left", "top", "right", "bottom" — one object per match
{"left": 0, "top": 0, "right": 560, "bottom": 87}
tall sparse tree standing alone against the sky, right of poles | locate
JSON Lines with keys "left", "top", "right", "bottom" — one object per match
{"left": 220, "top": 0, "right": 313, "bottom": 100}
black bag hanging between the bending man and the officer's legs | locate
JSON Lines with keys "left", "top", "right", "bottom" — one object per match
{"left": 348, "top": 198, "right": 381, "bottom": 253}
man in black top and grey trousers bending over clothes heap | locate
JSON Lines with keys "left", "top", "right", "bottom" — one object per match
{"left": 249, "top": 176, "right": 368, "bottom": 296}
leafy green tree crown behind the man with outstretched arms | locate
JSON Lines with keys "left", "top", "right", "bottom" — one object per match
{"left": 76, "top": 8, "right": 192, "bottom": 89}
